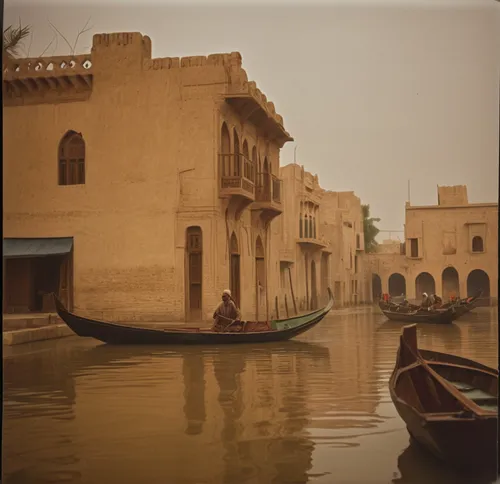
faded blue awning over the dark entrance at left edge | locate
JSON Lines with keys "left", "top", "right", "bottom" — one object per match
{"left": 3, "top": 237, "right": 73, "bottom": 258}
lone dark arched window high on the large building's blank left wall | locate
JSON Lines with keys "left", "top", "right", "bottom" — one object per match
{"left": 59, "top": 131, "right": 85, "bottom": 185}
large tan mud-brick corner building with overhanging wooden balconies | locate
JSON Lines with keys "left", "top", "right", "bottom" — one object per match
{"left": 3, "top": 33, "right": 292, "bottom": 321}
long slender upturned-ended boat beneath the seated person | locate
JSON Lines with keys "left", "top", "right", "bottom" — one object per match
{"left": 53, "top": 288, "right": 333, "bottom": 345}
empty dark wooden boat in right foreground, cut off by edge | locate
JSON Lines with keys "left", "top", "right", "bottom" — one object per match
{"left": 389, "top": 324, "right": 498, "bottom": 470}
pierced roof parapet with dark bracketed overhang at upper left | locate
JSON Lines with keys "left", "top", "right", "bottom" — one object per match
{"left": 2, "top": 55, "right": 92, "bottom": 104}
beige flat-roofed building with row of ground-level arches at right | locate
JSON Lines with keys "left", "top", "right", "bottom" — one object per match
{"left": 367, "top": 185, "right": 498, "bottom": 303}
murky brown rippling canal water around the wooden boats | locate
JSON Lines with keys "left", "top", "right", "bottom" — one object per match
{"left": 3, "top": 307, "right": 498, "bottom": 484}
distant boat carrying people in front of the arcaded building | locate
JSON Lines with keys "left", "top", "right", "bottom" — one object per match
{"left": 379, "top": 291, "right": 482, "bottom": 324}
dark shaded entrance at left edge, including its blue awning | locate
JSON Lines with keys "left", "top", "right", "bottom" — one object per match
{"left": 3, "top": 237, "right": 73, "bottom": 314}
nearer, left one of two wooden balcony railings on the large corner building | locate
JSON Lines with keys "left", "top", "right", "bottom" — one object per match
{"left": 219, "top": 153, "right": 256, "bottom": 202}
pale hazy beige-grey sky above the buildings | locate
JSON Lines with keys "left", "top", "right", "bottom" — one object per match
{"left": 4, "top": 0, "right": 500, "bottom": 235}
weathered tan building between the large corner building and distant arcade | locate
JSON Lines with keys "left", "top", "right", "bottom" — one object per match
{"left": 273, "top": 164, "right": 370, "bottom": 310}
